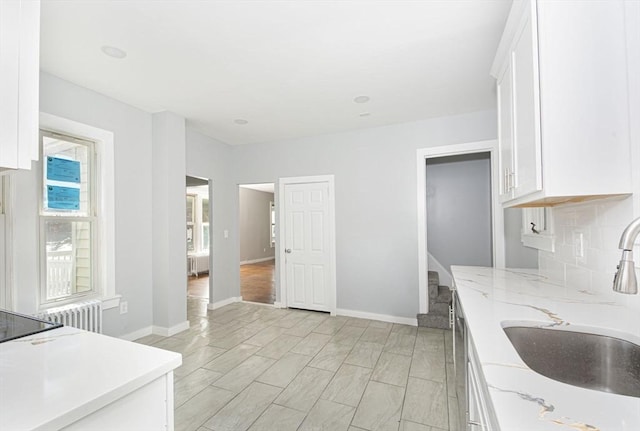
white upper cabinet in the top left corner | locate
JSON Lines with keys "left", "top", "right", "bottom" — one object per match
{"left": 0, "top": 0, "right": 40, "bottom": 171}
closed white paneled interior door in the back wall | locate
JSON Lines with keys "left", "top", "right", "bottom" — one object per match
{"left": 281, "top": 177, "right": 335, "bottom": 313}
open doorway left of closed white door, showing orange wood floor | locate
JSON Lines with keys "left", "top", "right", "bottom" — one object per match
{"left": 238, "top": 183, "right": 276, "bottom": 304}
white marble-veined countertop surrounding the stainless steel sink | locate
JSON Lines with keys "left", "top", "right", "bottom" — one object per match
{"left": 452, "top": 266, "right": 640, "bottom": 431}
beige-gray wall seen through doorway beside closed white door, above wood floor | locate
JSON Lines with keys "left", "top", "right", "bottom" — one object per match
{"left": 239, "top": 187, "right": 275, "bottom": 262}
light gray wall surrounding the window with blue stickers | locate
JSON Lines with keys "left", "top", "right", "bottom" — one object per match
{"left": 11, "top": 73, "right": 155, "bottom": 336}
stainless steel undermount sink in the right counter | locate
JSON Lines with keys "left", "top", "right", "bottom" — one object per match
{"left": 503, "top": 325, "right": 640, "bottom": 397}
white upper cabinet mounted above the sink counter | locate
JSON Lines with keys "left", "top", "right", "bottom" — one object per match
{"left": 491, "top": 0, "right": 632, "bottom": 207}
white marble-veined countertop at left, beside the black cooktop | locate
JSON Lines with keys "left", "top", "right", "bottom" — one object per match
{"left": 0, "top": 327, "right": 182, "bottom": 431}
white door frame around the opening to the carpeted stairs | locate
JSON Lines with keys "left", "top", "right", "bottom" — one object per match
{"left": 416, "top": 139, "right": 505, "bottom": 313}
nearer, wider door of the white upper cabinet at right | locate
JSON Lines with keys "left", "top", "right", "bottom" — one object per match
{"left": 510, "top": 8, "right": 542, "bottom": 198}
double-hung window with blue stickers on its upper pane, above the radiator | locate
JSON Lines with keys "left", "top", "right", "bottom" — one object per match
{"left": 40, "top": 131, "right": 98, "bottom": 304}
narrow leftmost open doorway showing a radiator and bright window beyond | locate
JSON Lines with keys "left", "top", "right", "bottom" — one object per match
{"left": 186, "top": 176, "right": 211, "bottom": 300}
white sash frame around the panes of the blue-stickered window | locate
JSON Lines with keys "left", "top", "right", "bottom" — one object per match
{"left": 37, "top": 128, "right": 101, "bottom": 309}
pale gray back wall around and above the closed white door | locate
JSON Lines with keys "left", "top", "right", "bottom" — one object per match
{"left": 232, "top": 111, "right": 496, "bottom": 318}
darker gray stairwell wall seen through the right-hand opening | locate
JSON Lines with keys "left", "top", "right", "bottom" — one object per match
{"left": 427, "top": 153, "right": 492, "bottom": 271}
